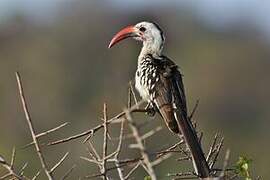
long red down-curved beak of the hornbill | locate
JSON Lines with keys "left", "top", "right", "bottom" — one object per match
{"left": 108, "top": 26, "right": 137, "bottom": 48}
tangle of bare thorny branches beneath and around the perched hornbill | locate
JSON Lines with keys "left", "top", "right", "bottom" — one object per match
{"left": 0, "top": 72, "right": 249, "bottom": 180}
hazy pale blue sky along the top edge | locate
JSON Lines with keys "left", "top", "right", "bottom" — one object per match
{"left": 0, "top": 0, "right": 270, "bottom": 37}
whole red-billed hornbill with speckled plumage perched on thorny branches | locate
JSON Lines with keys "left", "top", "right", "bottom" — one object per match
{"left": 109, "top": 22, "right": 210, "bottom": 178}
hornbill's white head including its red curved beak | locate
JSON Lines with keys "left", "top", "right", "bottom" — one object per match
{"left": 109, "top": 22, "right": 165, "bottom": 55}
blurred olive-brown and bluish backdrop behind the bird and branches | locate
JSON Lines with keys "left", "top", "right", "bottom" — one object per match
{"left": 0, "top": 0, "right": 270, "bottom": 179}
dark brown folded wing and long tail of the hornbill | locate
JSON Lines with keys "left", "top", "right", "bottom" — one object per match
{"left": 155, "top": 57, "right": 210, "bottom": 178}
